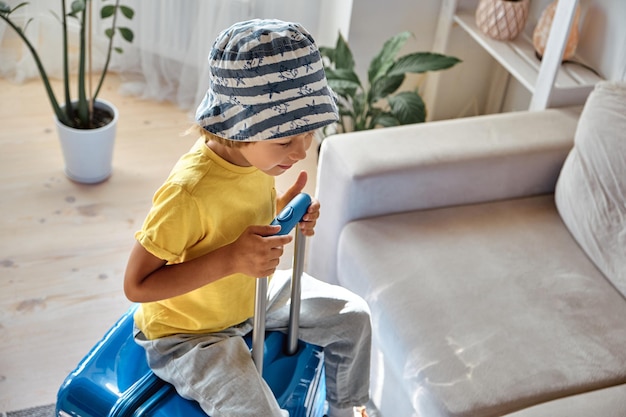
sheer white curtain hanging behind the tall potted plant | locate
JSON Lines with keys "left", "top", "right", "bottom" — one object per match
{"left": 0, "top": 0, "right": 336, "bottom": 109}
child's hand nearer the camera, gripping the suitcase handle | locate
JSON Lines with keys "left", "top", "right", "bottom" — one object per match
{"left": 230, "top": 225, "right": 292, "bottom": 277}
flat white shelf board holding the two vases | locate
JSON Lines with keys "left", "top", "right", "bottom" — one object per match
{"left": 454, "top": 12, "right": 601, "bottom": 106}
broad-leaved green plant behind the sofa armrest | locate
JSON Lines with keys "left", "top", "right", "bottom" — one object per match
{"left": 320, "top": 32, "right": 461, "bottom": 133}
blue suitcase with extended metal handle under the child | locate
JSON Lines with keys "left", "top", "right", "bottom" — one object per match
{"left": 56, "top": 194, "right": 326, "bottom": 417}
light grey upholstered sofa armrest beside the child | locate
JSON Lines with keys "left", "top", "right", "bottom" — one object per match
{"left": 308, "top": 107, "right": 581, "bottom": 283}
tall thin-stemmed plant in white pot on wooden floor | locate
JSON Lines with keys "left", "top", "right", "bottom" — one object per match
{"left": 0, "top": 0, "right": 134, "bottom": 184}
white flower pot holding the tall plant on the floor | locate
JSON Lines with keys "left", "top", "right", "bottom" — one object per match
{"left": 55, "top": 99, "right": 119, "bottom": 184}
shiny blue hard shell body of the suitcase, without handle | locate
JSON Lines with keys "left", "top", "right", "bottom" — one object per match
{"left": 56, "top": 306, "right": 326, "bottom": 417}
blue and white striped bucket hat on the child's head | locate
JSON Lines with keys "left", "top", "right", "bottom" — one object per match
{"left": 196, "top": 19, "right": 338, "bottom": 142}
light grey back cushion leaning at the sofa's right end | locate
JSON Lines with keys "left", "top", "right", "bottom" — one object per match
{"left": 556, "top": 81, "right": 626, "bottom": 296}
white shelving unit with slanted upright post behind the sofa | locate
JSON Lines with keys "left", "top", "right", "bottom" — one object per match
{"left": 424, "top": 0, "right": 601, "bottom": 120}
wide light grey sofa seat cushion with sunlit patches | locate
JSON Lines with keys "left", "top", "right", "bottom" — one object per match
{"left": 338, "top": 195, "right": 626, "bottom": 417}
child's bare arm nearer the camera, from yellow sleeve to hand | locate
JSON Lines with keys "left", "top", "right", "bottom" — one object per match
{"left": 124, "top": 226, "right": 292, "bottom": 302}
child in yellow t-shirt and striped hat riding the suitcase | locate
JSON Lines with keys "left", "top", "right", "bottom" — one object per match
{"left": 124, "top": 20, "right": 371, "bottom": 417}
